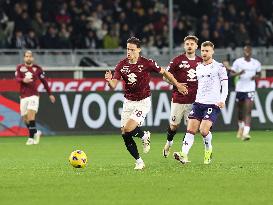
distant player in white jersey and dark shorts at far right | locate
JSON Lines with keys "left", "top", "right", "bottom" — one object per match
{"left": 232, "top": 46, "right": 261, "bottom": 140}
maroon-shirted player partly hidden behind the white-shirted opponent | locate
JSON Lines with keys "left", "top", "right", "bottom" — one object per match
{"left": 163, "top": 36, "right": 202, "bottom": 157}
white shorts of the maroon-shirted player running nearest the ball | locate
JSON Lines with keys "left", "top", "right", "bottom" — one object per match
{"left": 121, "top": 97, "right": 152, "bottom": 127}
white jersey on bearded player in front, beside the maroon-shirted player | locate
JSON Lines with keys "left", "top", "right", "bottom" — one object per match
{"left": 195, "top": 60, "right": 228, "bottom": 104}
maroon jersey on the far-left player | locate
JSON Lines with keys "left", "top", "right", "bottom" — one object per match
{"left": 15, "top": 64, "right": 51, "bottom": 98}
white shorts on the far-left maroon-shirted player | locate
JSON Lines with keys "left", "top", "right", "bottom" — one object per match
{"left": 20, "top": 95, "right": 39, "bottom": 116}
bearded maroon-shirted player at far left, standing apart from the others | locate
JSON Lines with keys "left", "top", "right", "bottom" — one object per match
{"left": 15, "top": 50, "right": 55, "bottom": 145}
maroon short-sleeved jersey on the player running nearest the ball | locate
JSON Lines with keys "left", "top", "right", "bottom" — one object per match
{"left": 113, "top": 56, "right": 161, "bottom": 101}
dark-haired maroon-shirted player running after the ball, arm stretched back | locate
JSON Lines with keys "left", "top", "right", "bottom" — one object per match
{"left": 105, "top": 37, "right": 188, "bottom": 170}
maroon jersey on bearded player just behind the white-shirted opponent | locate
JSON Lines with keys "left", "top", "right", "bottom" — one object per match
{"left": 167, "top": 54, "right": 202, "bottom": 104}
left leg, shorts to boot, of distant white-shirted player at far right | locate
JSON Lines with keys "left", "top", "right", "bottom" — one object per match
{"left": 236, "top": 92, "right": 245, "bottom": 139}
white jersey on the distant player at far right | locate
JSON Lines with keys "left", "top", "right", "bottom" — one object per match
{"left": 232, "top": 57, "right": 261, "bottom": 92}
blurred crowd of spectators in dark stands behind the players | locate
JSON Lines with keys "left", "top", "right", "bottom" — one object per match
{"left": 0, "top": 0, "right": 273, "bottom": 49}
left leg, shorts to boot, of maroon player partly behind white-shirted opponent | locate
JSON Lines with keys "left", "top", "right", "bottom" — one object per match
{"left": 163, "top": 102, "right": 184, "bottom": 157}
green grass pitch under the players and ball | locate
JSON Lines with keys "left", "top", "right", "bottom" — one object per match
{"left": 0, "top": 131, "right": 273, "bottom": 205}
